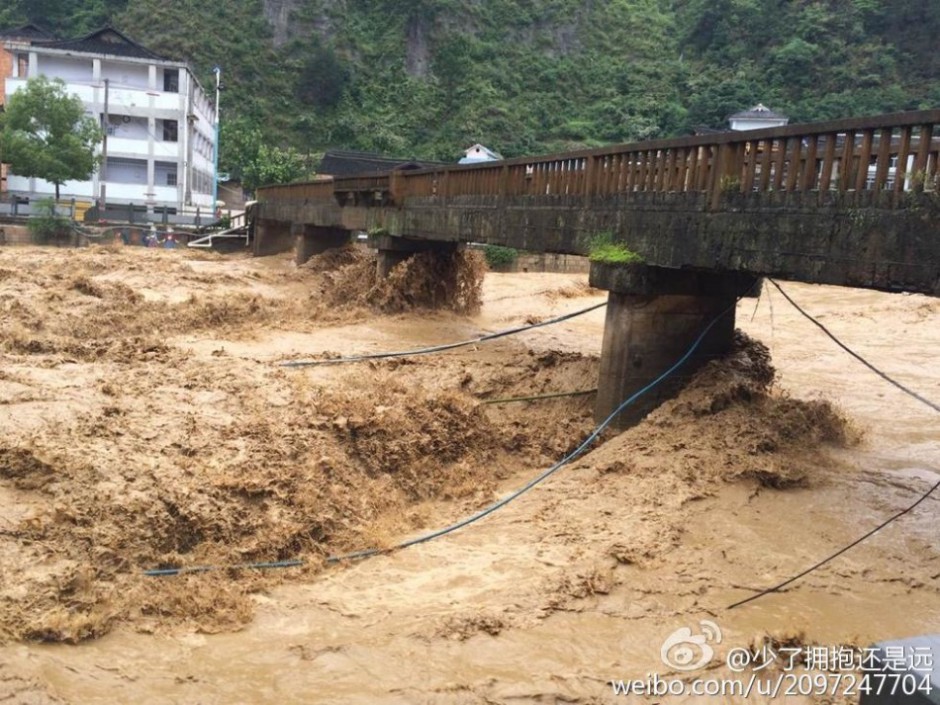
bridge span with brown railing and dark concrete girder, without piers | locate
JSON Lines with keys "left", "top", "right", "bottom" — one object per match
{"left": 258, "top": 110, "right": 940, "bottom": 295}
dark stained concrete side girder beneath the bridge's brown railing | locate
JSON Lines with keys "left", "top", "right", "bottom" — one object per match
{"left": 388, "top": 192, "right": 940, "bottom": 295}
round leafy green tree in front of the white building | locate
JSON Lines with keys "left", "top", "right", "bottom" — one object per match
{"left": 0, "top": 76, "right": 101, "bottom": 199}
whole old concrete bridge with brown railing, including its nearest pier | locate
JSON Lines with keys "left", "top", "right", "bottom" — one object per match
{"left": 254, "top": 110, "right": 940, "bottom": 425}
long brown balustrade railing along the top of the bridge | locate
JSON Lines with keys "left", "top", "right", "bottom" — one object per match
{"left": 260, "top": 110, "right": 940, "bottom": 208}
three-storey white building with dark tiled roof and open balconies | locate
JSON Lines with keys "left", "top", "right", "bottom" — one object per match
{"left": 0, "top": 27, "right": 215, "bottom": 212}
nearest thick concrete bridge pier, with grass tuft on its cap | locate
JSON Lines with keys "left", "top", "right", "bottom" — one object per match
{"left": 590, "top": 263, "right": 759, "bottom": 430}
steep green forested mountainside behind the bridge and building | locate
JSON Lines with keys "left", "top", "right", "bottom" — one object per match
{"left": 0, "top": 0, "right": 940, "bottom": 169}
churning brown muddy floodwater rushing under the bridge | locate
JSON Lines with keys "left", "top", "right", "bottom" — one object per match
{"left": 0, "top": 247, "right": 940, "bottom": 704}
